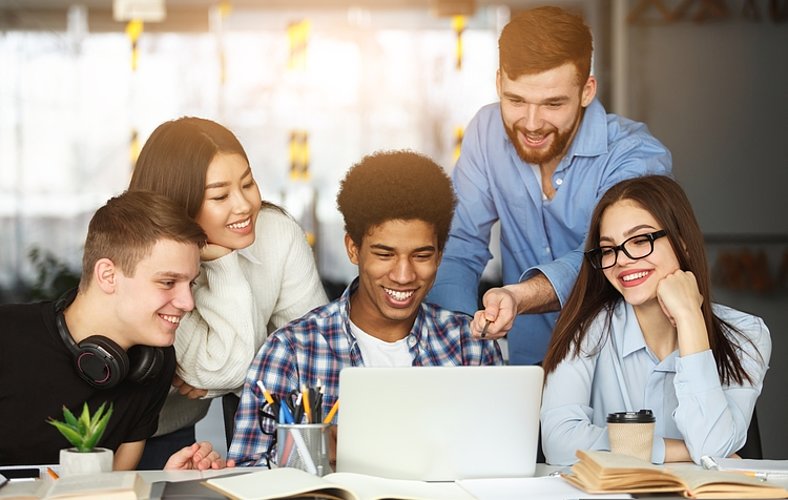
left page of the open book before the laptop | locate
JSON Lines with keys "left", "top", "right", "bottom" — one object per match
{"left": 205, "top": 468, "right": 359, "bottom": 500}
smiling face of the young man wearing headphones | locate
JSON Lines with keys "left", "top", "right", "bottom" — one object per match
{"left": 114, "top": 239, "right": 200, "bottom": 348}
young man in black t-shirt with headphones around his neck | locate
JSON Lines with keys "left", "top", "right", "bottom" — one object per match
{"left": 0, "top": 191, "right": 232, "bottom": 470}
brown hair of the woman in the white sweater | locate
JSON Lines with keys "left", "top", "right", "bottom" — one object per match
{"left": 129, "top": 116, "right": 279, "bottom": 218}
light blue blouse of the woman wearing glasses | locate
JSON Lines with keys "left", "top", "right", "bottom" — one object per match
{"left": 541, "top": 300, "right": 772, "bottom": 465}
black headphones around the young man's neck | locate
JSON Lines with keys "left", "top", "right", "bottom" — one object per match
{"left": 55, "top": 288, "right": 164, "bottom": 389}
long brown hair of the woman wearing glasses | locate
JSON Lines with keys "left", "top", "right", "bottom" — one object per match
{"left": 543, "top": 175, "right": 752, "bottom": 384}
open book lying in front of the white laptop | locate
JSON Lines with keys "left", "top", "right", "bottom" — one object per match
{"left": 204, "top": 468, "right": 473, "bottom": 500}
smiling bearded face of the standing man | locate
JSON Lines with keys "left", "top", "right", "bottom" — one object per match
{"left": 496, "top": 63, "right": 596, "bottom": 165}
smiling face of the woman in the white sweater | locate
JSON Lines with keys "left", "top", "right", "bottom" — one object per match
{"left": 195, "top": 153, "right": 261, "bottom": 250}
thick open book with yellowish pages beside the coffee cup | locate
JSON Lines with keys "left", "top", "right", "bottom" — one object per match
{"left": 563, "top": 450, "right": 788, "bottom": 499}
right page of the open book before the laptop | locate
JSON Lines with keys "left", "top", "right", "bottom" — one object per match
{"left": 324, "top": 472, "right": 474, "bottom": 500}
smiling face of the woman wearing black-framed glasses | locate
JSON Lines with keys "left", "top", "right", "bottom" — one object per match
{"left": 599, "top": 200, "right": 680, "bottom": 306}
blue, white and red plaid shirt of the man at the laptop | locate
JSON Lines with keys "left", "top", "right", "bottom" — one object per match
{"left": 227, "top": 279, "right": 503, "bottom": 465}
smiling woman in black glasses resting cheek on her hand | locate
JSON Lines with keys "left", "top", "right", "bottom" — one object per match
{"left": 541, "top": 176, "right": 771, "bottom": 464}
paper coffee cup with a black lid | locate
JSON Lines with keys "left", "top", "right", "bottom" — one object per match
{"left": 607, "top": 410, "right": 656, "bottom": 462}
